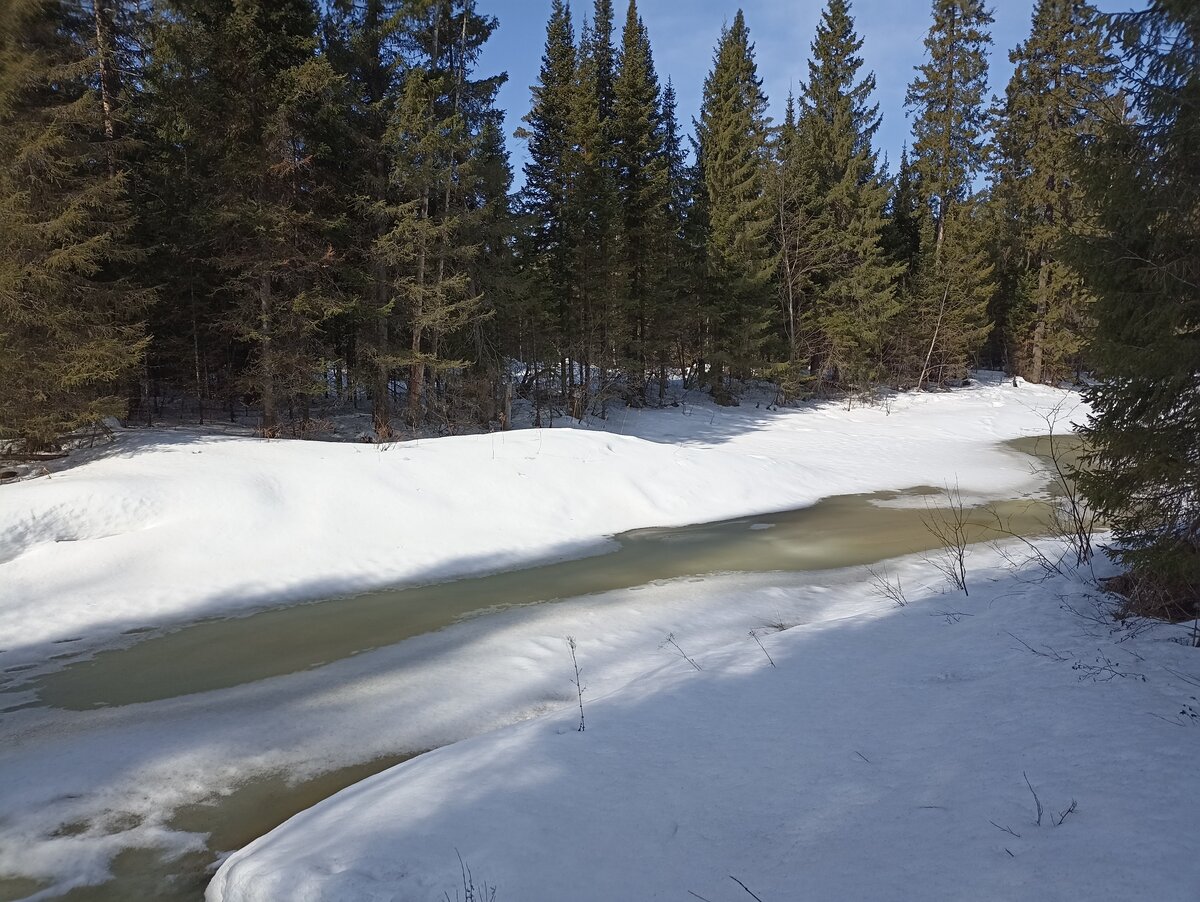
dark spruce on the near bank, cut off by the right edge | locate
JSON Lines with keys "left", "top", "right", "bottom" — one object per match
{"left": 1070, "top": 0, "right": 1200, "bottom": 618}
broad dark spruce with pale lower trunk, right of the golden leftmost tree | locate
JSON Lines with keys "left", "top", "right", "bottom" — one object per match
{"left": 143, "top": 0, "right": 344, "bottom": 434}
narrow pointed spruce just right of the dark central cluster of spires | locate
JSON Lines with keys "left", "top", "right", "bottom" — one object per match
{"left": 697, "top": 10, "right": 775, "bottom": 399}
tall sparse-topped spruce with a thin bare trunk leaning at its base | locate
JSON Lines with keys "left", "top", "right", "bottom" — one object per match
{"left": 895, "top": 0, "right": 994, "bottom": 387}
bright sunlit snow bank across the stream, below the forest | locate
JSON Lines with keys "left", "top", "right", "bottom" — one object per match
{"left": 0, "top": 378, "right": 1082, "bottom": 667}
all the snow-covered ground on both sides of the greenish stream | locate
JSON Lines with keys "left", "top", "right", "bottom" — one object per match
{"left": 0, "top": 378, "right": 1200, "bottom": 902}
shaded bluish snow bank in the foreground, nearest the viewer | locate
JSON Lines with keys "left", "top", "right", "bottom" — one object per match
{"left": 208, "top": 549, "right": 1200, "bottom": 902}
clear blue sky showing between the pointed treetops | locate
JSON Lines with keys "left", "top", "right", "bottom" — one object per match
{"left": 476, "top": 0, "right": 1033, "bottom": 184}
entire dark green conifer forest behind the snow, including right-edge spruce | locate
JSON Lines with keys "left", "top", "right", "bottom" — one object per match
{"left": 0, "top": 0, "right": 1200, "bottom": 609}
